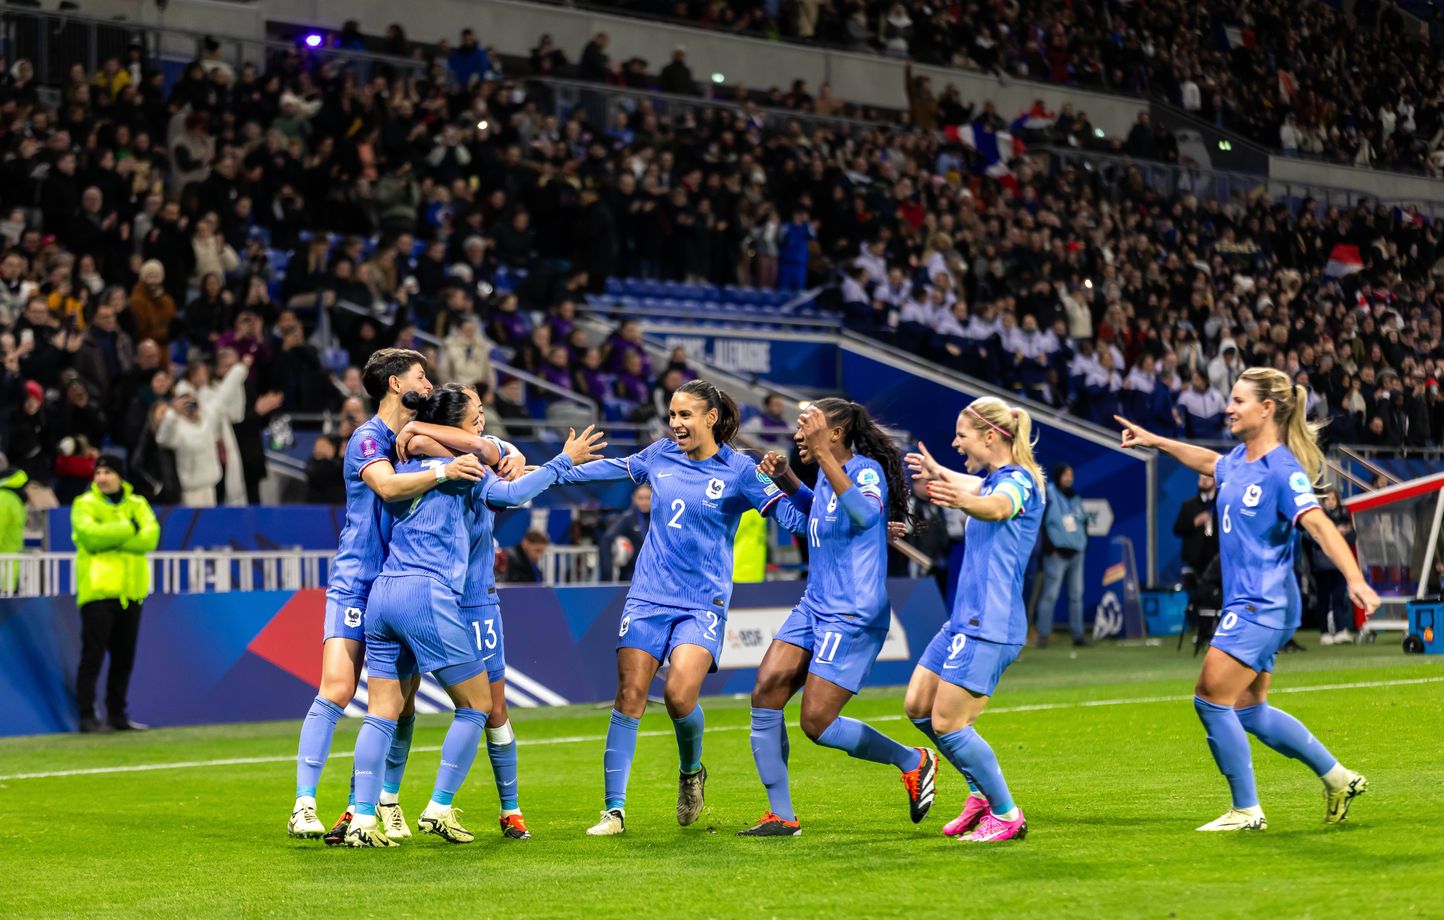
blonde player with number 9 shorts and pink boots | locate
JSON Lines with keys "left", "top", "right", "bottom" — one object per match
{"left": 904, "top": 396, "right": 1044, "bottom": 842}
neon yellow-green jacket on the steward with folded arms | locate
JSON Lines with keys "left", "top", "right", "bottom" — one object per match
{"left": 71, "top": 482, "right": 160, "bottom": 605}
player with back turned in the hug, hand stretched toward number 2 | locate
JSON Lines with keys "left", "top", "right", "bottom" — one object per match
{"left": 345, "top": 384, "right": 602, "bottom": 846}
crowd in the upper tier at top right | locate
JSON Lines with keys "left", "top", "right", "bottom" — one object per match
{"left": 574, "top": 0, "right": 1444, "bottom": 176}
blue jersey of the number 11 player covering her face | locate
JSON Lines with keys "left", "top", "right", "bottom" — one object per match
{"left": 777, "top": 455, "right": 890, "bottom": 628}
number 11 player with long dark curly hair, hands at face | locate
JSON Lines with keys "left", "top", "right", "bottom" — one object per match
{"left": 738, "top": 399, "right": 937, "bottom": 836}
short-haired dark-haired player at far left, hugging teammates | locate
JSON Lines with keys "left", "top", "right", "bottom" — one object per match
{"left": 287, "top": 348, "right": 505, "bottom": 845}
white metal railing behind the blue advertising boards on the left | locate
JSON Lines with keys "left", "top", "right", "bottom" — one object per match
{"left": 0, "top": 546, "right": 599, "bottom": 598}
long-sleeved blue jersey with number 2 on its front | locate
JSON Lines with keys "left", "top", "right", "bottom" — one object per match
{"left": 562, "top": 441, "right": 783, "bottom": 614}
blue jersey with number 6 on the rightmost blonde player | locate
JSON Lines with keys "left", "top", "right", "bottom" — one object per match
{"left": 1213, "top": 445, "right": 1318, "bottom": 630}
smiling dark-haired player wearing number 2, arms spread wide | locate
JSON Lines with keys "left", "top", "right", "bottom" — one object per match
{"left": 562, "top": 380, "right": 783, "bottom": 836}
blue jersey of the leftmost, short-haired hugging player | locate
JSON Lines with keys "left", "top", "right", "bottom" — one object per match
{"left": 326, "top": 416, "right": 396, "bottom": 607}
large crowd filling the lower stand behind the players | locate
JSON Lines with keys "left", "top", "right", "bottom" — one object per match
{"left": 0, "top": 19, "right": 1444, "bottom": 517}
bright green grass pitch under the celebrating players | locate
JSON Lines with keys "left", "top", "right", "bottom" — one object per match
{"left": 0, "top": 638, "right": 1444, "bottom": 919}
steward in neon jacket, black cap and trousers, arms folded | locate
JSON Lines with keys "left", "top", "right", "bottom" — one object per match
{"left": 71, "top": 455, "right": 160, "bottom": 732}
